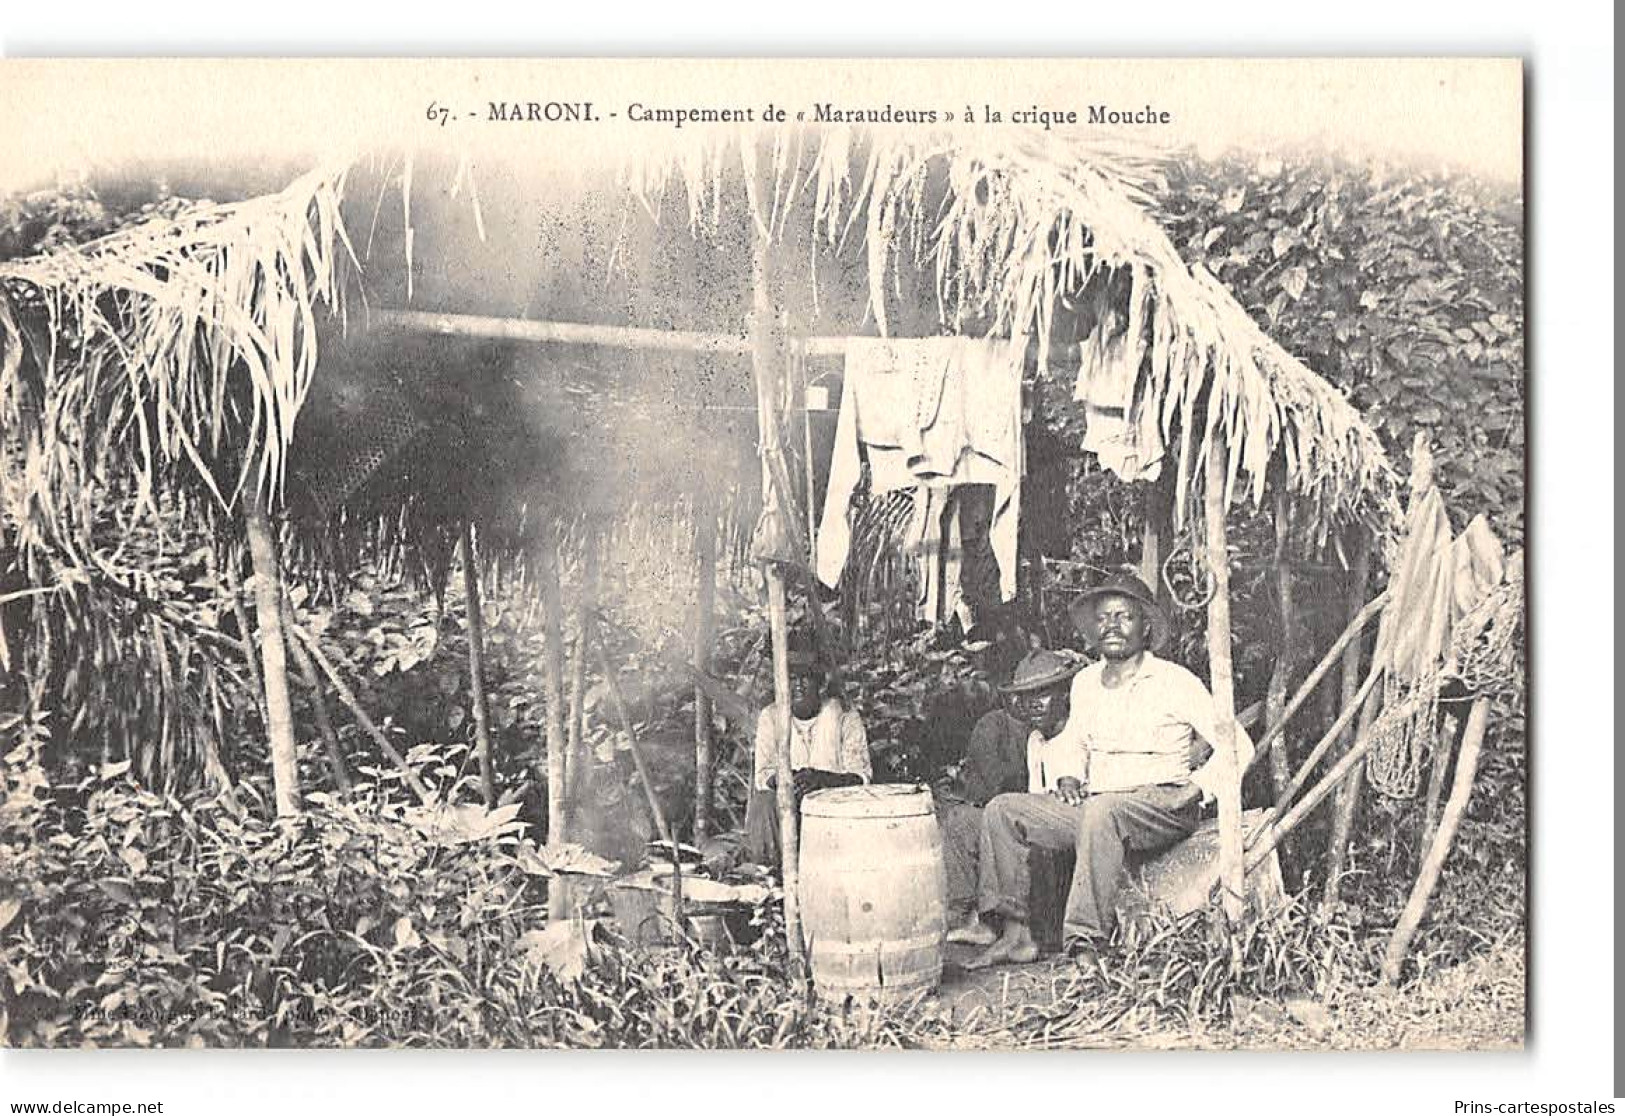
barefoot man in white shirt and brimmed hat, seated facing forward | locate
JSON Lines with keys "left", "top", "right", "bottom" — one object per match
{"left": 970, "top": 573, "right": 1253, "bottom": 968}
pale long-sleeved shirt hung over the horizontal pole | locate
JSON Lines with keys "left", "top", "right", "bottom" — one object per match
{"left": 817, "top": 336, "right": 1027, "bottom": 601}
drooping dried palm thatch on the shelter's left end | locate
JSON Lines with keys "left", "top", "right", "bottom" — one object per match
{"left": 0, "top": 167, "right": 359, "bottom": 555}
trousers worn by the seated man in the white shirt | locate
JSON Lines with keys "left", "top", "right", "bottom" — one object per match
{"left": 977, "top": 783, "right": 1203, "bottom": 941}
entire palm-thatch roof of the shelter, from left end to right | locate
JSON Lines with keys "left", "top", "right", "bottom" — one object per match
{"left": 0, "top": 127, "right": 1398, "bottom": 766}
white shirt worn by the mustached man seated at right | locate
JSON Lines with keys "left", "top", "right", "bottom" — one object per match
{"left": 1045, "top": 651, "right": 1253, "bottom": 799}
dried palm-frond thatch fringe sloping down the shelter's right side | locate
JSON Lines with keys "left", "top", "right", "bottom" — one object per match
{"left": 622, "top": 127, "right": 1399, "bottom": 544}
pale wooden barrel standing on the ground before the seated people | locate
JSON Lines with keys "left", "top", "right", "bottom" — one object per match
{"left": 801, "top": 785, "right": 947, "bottom": 1004}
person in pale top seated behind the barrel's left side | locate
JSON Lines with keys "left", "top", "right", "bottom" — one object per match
{"left": 744, "top": 640, "right": 873, "bottom": 866}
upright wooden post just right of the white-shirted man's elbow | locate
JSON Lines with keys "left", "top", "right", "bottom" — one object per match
{"left": 1203, "top": 434, "right": 1246, "bottom": 929}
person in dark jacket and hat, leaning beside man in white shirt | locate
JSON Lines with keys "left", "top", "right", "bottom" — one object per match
{"left": 938, "top": 651, "right": 1082, "bottom": 945}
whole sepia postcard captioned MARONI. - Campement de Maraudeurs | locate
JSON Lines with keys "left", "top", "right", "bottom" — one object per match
{"left": 0, "top": 57, "right": 1534, "bottom": 1065}
